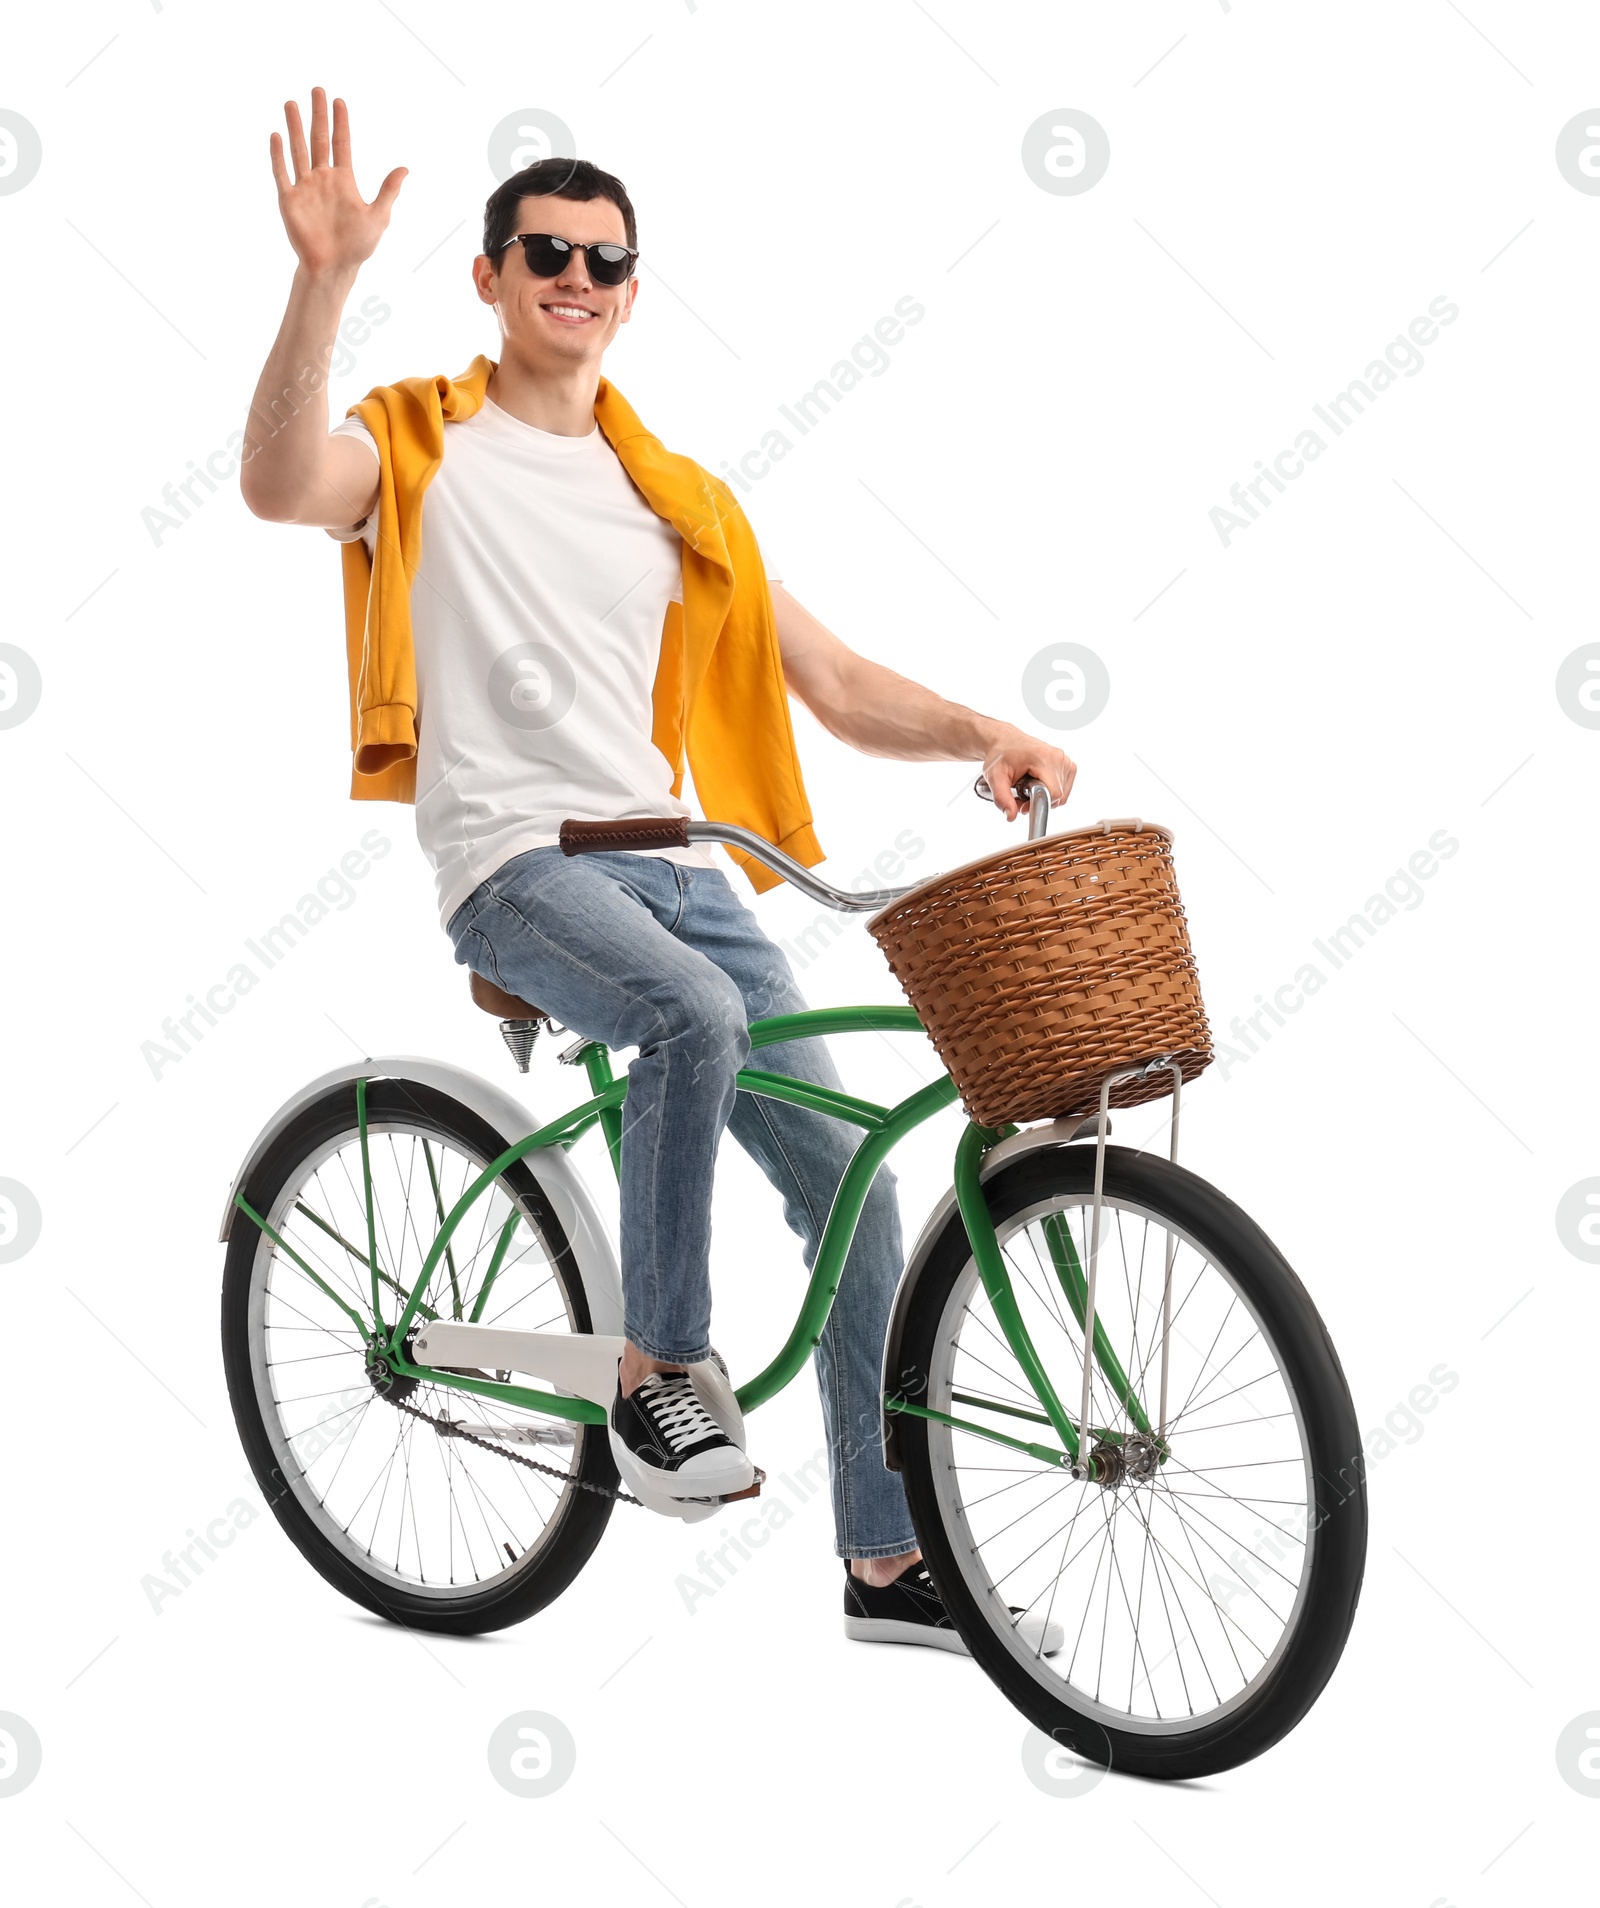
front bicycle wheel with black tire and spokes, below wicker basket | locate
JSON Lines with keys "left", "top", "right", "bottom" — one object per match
{"left": 894, "top": 1147, "right": 1367, "bottom": 1778}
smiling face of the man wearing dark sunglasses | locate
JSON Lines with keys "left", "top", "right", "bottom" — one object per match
{"left": 473, "top": 198, "right": 639, "bottom": 370}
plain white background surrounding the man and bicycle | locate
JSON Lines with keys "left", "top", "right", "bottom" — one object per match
{"left": 0, "top": 0, "right": 1600, "bottom": 1908}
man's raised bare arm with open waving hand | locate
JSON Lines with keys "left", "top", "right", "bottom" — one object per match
{"left": 238, "top": 86, "right": 406, "bottom": 529}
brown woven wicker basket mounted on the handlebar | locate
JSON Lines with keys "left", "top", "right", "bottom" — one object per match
{"left": 868, "top": 820, "right": 1213, "bottom": 1126}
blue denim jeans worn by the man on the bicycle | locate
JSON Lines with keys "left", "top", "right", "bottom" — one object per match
{"left": 448, "top": 845, "right": 917, "bottom": 1557}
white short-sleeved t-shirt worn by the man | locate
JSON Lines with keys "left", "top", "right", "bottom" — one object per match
{"left": 328, "top": 399, "right": 778, "bottom": 923}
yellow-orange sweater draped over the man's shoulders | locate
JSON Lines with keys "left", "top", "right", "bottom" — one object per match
{"left": 343, "top": 355, "right": 822, "bottom": 893}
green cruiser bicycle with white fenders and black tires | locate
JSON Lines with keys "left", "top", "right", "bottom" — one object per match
{"left": 221, "top": 778, "right": 1367, "bottom": 1778}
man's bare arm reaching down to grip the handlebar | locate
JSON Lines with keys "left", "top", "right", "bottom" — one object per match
{"left": 772, "top": 584, "right": 1077, "bottom": 820}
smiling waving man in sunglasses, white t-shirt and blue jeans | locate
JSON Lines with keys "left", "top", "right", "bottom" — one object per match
{"left": 240, "top": 88, "right": 1074, "bottom": 1650}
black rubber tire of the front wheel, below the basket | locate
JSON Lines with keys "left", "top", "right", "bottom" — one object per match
{"left": 894, "top": 1145, "right": 1367, "bottom": 1778}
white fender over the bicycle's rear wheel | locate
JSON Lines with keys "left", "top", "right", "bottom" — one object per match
{"left": 217, "top": 1053, "right": 622, "bottom": 1334}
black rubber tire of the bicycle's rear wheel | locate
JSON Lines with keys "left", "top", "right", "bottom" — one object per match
{"left": 221, "top": 1080, "right": 618, "bottom": 1635}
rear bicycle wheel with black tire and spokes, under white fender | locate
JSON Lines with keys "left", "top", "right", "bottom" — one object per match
{"left": 221, "top": 1080, "right": 618, "bottom": 1633}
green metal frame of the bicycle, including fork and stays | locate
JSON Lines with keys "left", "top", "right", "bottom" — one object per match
{"left": 235, "top": 1007, "right": 1150, "bottom": 1467}
